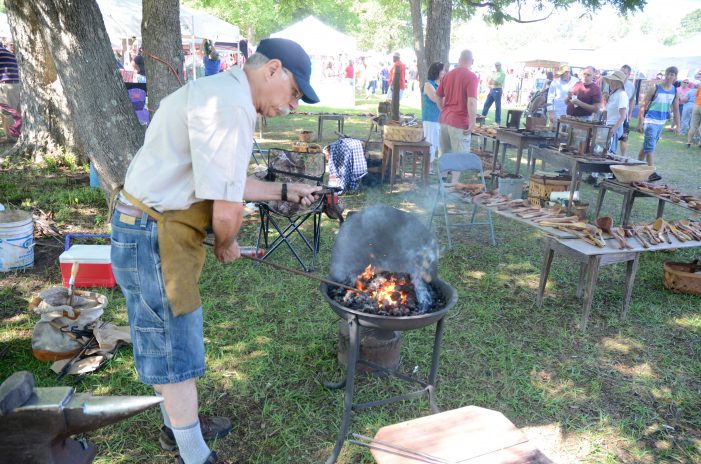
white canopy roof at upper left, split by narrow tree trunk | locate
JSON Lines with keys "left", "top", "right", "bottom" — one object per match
{"left": 97, "top": 0, "right": 240, "bottom": 47}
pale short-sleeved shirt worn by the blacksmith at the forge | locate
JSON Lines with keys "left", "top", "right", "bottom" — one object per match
{"left": 124, "top": 67, "right": 256, "bottom": 211}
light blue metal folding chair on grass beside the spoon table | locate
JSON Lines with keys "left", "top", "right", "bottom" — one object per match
{"left": 428, "top": 153, "right": 497, "bottom": 248}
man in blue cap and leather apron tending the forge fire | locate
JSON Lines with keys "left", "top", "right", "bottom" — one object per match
{"left": 112, "top": 39, "right": 319, "bottom": 464}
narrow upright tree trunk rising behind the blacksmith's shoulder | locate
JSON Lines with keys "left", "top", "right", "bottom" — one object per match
{"left": 141, "top": 0, "right": 183, "bottom": 112}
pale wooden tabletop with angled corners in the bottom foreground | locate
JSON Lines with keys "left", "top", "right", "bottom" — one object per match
{"left": 372, "top": 406, "right": 552, "bottom": 464}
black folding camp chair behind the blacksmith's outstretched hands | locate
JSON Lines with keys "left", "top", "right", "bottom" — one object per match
{"left": 256, "top": 148, "right": 326, "bottom": 272}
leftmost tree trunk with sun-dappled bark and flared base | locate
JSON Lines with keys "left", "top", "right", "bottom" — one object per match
{"left": 5, "top": 0, "right": 85, "bottom": 161}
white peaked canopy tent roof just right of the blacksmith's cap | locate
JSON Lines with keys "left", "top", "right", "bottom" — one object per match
{"left": 270, "top": 16, "right": 357, "bottom": 56}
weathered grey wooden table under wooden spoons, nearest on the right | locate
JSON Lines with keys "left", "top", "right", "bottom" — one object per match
{"left": 535, "top": 237, "right": 701, "bottom": 330}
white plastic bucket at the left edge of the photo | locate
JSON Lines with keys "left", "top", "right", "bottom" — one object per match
{"left": 0, "top": 210, "right": 34, "bottom": 272}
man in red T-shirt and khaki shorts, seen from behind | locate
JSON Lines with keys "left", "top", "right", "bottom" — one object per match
{"left": 436, "top": 50, "right": 479, "bottom": 183}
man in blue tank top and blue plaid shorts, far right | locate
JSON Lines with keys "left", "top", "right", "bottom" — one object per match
{"left": 638, "top": 66, "right": 681, "bottom": 182}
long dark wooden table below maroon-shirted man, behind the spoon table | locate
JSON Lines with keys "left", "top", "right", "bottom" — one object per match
{"left": 528, "top": 145, "right": 645, "bottom": 212}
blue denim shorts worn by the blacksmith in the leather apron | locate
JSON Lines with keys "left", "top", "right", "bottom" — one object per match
{"left": 112, "top": 211, "right": 205, "bottom": 385}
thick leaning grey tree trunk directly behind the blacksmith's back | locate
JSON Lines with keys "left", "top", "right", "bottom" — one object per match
{"left": 5, "top": 0, "right": 144, "bottom": 192}
